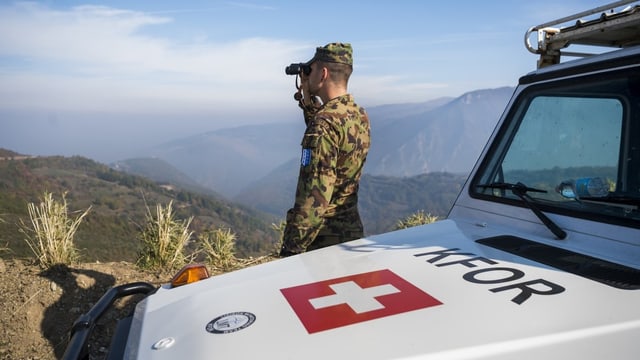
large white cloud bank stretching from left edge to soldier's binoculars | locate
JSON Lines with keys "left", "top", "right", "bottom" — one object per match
{"left": 0, "top": 3, "right": 309, "bottom": 112}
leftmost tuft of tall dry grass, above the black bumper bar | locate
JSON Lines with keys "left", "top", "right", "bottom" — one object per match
{"left": 20, "top": 192, "right": 91, "bottom": 269}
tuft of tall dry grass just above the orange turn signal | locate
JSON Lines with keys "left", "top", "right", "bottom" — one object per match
{"left": 136, "top": 201, "right": 193, "bottom": 270}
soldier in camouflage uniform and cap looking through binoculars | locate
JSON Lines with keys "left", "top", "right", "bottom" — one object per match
{"left": 280, "top": 43, "right": 370, "bottom": 257}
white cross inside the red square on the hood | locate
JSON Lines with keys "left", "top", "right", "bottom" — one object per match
{"left": 309, "top": 281, "right": 400, "bottom": 314}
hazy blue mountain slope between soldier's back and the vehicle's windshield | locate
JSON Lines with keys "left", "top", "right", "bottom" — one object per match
{"left": 365, "top": 87, "right": 513, "bottom": 176}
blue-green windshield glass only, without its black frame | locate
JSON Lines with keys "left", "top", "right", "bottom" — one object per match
{"left": 502, "top": 96, "right": 622, "bottom": 199}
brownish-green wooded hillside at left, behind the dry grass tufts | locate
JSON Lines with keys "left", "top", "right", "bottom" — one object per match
{"left": 0, "top": 150, "right": 277, "bottom": 261}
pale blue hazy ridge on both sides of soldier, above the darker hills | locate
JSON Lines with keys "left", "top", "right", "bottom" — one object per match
{"left": 134, "top": 87, "right": 513, "bottom": 198}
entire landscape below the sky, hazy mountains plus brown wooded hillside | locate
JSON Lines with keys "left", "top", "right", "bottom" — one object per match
{"left": 0, "top": 88, "right": 513, "bottom": 260}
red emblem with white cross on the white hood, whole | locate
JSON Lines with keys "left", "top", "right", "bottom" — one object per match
{"left": 280, "top": 270, "right": 442, "bottom": 334}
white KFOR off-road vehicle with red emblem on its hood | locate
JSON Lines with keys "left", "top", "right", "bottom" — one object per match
{"left": 65, "top": 1, "right": 640, "bottom": 360}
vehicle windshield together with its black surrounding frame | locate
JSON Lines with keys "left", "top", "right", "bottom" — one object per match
{"left": 471, "top": 71, "right": 640, "bottom": 226}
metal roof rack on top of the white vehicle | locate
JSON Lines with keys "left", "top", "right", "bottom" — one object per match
{"left": 524, "top": 0, "right": 640, "bottom": 68}
